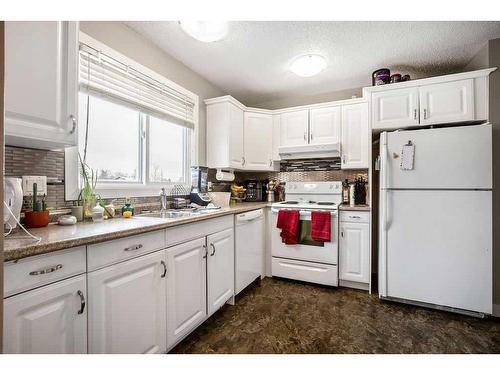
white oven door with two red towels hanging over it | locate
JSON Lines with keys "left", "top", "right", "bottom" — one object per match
{"left": 271, "top": 208, "right": 338, "bottom": 265}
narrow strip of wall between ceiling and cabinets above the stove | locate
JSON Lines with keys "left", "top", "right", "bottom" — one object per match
{"left": 252, "top": 87, "right": 363, "bottom": 109}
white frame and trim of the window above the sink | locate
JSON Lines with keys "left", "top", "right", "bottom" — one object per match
{"left": 65, "top": 32, "right": 200, "bottom": 200}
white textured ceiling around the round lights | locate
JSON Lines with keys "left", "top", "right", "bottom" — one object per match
{"left": 127, "top": 21, "right": 500, "bottom": 105}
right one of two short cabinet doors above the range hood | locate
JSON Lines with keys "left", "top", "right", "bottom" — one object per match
{"left": 309, "top": 106, "right": 342, "bottom": 144}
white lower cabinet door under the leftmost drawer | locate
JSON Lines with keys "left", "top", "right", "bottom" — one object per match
{"left": 3, "top": 275, "right": 87, "bottom": 354}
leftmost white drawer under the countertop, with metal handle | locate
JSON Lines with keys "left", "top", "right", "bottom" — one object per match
{"left": 4, "top": 246, "right": 86, "bottom": 297}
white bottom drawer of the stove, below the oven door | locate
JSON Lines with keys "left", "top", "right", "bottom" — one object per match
{"left": 272, "top": 257, "right": 338, "bottom": 286}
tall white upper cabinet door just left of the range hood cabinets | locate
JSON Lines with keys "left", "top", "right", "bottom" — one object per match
{"left": 243, "top": 112, "right": 273, "bottom": 170}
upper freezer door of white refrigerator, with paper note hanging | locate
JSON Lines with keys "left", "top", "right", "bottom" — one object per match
{"left": 381, "top": 124, "right": 492, "bottom": 189}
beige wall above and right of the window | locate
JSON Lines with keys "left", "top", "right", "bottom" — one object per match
{"left": 80, "top": 21, "right": 225, "bottom": 165}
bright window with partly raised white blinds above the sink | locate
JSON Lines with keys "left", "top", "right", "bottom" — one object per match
{"left": 65, "top": 33, "right": 198, "bottom": 199}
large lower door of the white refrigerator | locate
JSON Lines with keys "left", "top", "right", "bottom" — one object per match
{"left": 380, "top": 191, "right": 492, "bottom": 314}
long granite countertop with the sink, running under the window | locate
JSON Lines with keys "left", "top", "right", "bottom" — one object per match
{"left": 4, "top": 202, "right": 268, "bottom": 262}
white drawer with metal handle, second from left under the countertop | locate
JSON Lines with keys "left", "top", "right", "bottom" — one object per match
{"left": 87, "top": 230, "right": 166, "bottom": 271}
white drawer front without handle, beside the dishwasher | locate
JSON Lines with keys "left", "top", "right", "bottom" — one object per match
{"left": 167, "top": 215, "right": 234, "bottom": 247}
